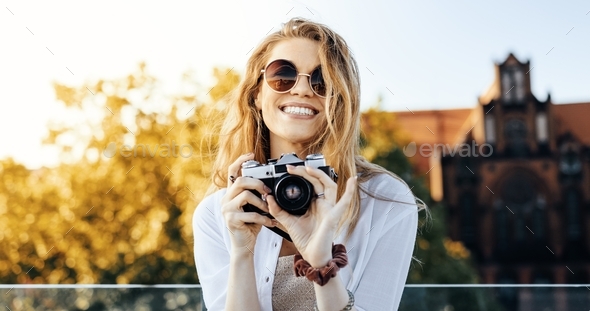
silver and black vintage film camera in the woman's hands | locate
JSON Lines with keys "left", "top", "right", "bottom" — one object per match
{"left": 242, "top": 153, "right": 338, "bottom": 219}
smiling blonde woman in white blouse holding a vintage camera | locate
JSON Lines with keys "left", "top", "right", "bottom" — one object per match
{"left": 193, "top": 19, "right": 422, "bottom": 311}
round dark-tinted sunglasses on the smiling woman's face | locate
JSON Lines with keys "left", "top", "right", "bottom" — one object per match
{"left": 260, "top": 59, "right": 326, "bottom": 97}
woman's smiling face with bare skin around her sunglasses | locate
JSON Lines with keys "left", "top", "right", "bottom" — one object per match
{"left": 255, "top": 38, "right": 326, "bottom": 159}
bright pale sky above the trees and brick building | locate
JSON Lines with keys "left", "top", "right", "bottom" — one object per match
{"left": 0, "top": 0, "right": 590, "bottom": 168}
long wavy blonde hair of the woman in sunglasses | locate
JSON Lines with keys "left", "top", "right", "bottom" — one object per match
{"left": 209, "top": 18, "right": 424, "bottom": 236}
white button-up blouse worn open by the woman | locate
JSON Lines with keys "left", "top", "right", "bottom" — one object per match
{"left": 193, "top": 174, "right": 418, "bottom": 311}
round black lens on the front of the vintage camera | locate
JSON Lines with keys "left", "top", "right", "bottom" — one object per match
{"left": 274, "top": 174, "right": 313, "bottom": 215}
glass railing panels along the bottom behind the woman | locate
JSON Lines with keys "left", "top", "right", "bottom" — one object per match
{"left": 0, "top": 284, "right": 590, "bottom": 311}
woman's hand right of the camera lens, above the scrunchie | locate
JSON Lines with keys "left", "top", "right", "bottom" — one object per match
{"left": 267, "top": 165, "right": 356, "bottom": 268}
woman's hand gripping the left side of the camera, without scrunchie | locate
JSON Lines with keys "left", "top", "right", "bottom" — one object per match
{"left": 221, "top": 153, "right": 277, "bottom": 253}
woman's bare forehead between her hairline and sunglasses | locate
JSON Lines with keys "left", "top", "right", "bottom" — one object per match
{"left": 267, "top": 38, "right": 320, "bottom": 71}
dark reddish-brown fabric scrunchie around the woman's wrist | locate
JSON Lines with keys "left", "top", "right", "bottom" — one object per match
{"left": 293, "top": 244, "right": 348, "bottom": 286}
